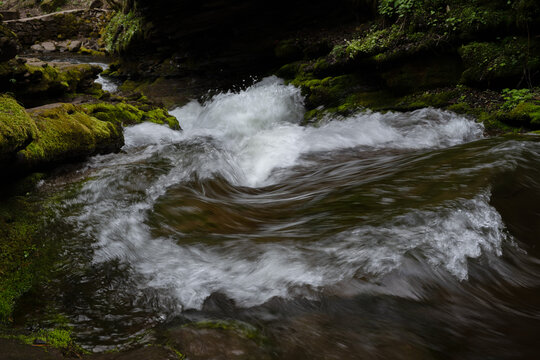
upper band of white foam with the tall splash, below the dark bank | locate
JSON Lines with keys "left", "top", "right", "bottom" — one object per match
{"left": 121, "top": 77, "right": 483, "bottom": 187}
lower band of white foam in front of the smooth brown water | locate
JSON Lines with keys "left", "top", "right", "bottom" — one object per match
{"left": 86, "top": 193, "right": 506, "bottom": 310}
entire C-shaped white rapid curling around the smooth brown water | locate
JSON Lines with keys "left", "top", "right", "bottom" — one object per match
{"left": 60, "top": 77, "right": 511, "bottom": 311}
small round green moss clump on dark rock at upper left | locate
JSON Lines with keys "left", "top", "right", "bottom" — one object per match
{"left": 103, "top": 11, "right": 144, "bottom": 54}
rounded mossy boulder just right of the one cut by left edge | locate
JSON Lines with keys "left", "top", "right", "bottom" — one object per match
{"left": 17, "top": 104, "right": 124, "bottom": 169}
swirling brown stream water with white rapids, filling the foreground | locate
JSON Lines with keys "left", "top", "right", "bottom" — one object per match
{"left": 22, "top": 78, "right": 540, "bottom": 359}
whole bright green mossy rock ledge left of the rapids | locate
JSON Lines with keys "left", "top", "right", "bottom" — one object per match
{"left": 0, "top": 95, "right": 180, "bottom": 179}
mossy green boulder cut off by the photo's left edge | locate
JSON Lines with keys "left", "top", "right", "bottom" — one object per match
{"left": 0, "top": 95, "right": 37, "bottom": 161}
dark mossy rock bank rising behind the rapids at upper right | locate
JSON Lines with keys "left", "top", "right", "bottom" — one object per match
{"left": 270, "top": 0, "right": 540, "bottom": 131}
